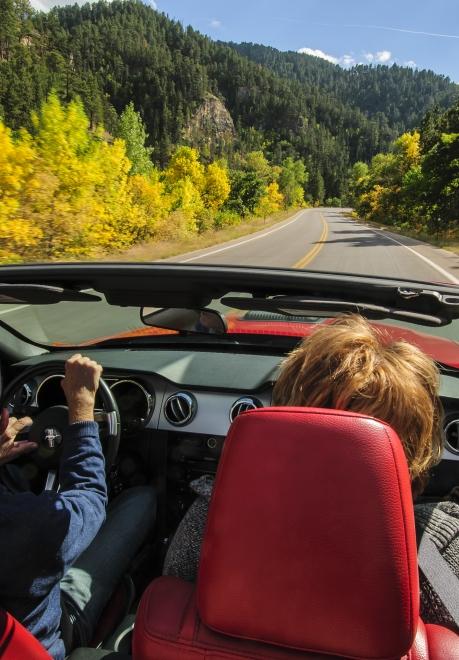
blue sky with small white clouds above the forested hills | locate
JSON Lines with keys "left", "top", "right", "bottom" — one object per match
{"left": 32, "top": 0, "right": 459, "bottom": 82}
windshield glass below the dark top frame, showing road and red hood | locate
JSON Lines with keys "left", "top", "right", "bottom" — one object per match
{"left": 0, "top": 290, "right": 459, "bottom": 366}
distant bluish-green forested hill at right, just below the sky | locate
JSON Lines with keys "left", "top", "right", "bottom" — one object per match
{"left": 228, "top": 43, "right": 459, "bottom": 134}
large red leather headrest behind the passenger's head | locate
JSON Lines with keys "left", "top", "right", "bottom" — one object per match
{"left": 198, "top": 408, "right": 419, "bottom": 659}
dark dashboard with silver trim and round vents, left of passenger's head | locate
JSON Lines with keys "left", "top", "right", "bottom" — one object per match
{"left": 8, "top": 349, "right": 278, "bottom": 436}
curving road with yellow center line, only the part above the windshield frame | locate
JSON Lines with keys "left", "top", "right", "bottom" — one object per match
{"left": 175, "top": 208, "right": 459, "bottom": 284}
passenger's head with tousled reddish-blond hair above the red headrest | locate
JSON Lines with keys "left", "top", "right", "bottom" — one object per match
{"left": 273, "top": 315, "right": 442, "bottom": 492}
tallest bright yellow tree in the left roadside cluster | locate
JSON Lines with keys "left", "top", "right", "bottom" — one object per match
{"left": 28, "top": 94, "right": 140, "bottom": 258}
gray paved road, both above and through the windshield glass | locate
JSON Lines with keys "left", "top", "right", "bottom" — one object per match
{"left": 0, "top": 208, "right": 459, "bottom": 343}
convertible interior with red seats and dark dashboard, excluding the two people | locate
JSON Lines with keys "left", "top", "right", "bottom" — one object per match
{"left": 0, "top": 264, "right": 459, "bottom": 660}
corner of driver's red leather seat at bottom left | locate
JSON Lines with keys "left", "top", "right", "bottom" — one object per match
{"left": 0, "top": 610, "right": 52, "bottom": 660}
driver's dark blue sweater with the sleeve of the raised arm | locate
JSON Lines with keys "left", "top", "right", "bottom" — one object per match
{"left": 0, "top": 422, "right": 107, "bottom": 600}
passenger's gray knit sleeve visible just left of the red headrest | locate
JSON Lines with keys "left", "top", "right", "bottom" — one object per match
{"left": 163, "top": 476, "right": 213, "bottom": 582}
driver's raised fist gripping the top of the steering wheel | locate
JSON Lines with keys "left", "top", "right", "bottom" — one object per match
{"left": 61, "top": 353, "right": 102, "bottom": 424}
